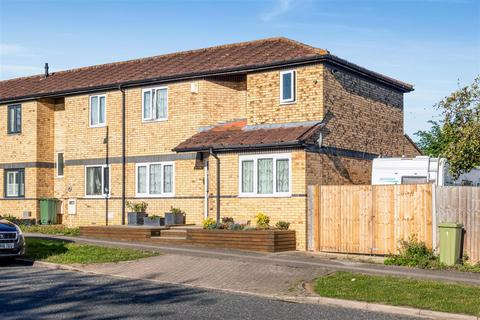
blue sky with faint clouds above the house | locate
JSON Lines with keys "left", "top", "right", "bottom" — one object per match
{"left": 0, "top": 0, "right": 480, "bottom": 134}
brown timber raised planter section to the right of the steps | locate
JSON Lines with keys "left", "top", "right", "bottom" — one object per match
{"left": 187, "top": 229, "right": 296, "bottom": 252}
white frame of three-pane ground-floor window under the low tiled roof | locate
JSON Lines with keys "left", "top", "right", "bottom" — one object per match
{"left": 238, "top": 153, "right": 292, "bottom": 198}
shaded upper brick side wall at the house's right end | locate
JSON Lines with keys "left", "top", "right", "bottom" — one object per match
{"left": 323, "top": 65, "right": 404, "bottom": 156}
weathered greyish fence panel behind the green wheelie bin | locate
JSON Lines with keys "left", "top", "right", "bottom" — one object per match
{"left": 435, "top": 187, "right": 480, "bottom": 262}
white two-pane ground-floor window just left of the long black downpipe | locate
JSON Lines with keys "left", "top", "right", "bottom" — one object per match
{"left": 85, "top": 165, "right": 110, "bottom": 198}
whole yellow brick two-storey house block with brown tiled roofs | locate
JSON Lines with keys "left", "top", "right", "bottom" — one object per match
{"left": 0, "top": 38, "right": 420, "bottom": 249}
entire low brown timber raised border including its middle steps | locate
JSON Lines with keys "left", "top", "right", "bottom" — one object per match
{"left": 80, "top": 226, "right": 296, "bottom": 252}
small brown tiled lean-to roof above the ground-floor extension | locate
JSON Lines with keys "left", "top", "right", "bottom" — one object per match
{"left": 173, "top": 121, "right": 320, "bottom": 152}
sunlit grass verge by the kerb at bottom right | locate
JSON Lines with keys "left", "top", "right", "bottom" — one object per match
{"left": 314, "top": 272, "right": 480, "bottom": 316}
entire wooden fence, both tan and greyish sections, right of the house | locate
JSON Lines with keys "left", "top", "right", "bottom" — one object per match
{"left": 307, "top": 184, "right": 480, "bottom": 261}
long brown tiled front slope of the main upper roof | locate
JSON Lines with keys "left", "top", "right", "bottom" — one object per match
{"left": 0, "top": 38, "right": 328, "bottom": 101}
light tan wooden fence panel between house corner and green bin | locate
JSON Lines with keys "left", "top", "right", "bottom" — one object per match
{"left": 308, "top": 184, "right": 432, "bottom": 254}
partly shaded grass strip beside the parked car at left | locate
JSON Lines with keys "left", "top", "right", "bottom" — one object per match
{"left": 26, "top": 238, "right": 159, "bottom": 264}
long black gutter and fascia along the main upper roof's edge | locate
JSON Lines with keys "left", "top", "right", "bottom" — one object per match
{"left": 0, "top": 54, "right": 414, "bottom": 103}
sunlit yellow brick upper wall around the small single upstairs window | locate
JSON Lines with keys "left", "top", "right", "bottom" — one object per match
{"left": 246, "top": 65, "right": 323, "bottom": 124}
